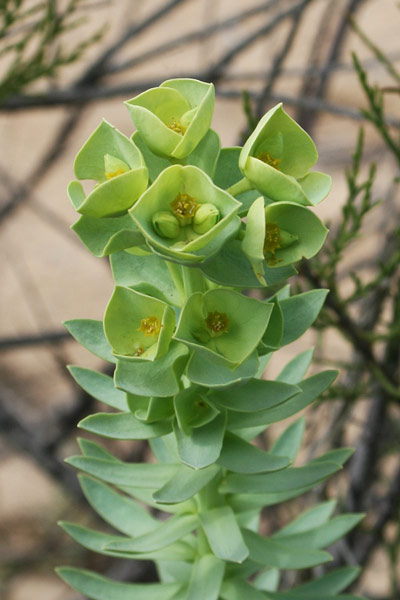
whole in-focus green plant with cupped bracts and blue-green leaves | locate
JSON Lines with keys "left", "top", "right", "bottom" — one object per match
{"left": 59, "top": 80, "right": 362, "bottom": 600}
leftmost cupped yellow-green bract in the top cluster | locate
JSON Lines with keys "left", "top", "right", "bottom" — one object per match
{"left": 68, "top": 120, "right": 148, "bottom": 218}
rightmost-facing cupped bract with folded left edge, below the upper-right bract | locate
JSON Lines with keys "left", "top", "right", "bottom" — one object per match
{"left": 242, "top": 196, "right": 328, "bottom": 285}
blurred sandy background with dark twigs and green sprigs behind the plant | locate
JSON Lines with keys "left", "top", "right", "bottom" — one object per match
{"left": 0, "top": 0, "right": 400, "bottom": 600}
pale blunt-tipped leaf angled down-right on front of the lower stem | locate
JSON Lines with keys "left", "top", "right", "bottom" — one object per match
{"left": 199, "top": 506, "right": 249, "bottom": 563}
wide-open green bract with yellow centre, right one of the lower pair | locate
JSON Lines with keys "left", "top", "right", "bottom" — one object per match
{"left": 174, "top": 289, "right": 273, "bottom": 366}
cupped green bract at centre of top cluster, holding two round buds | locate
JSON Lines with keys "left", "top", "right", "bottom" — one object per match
{"left": 129, "top": 165, "right": 240, "bottom": 261}
